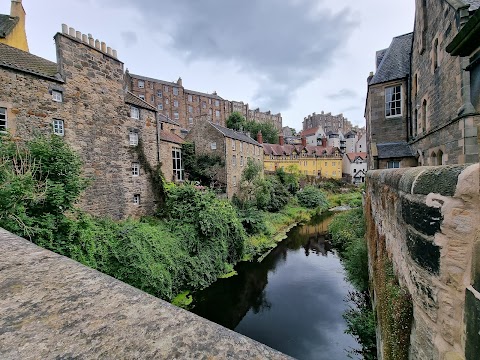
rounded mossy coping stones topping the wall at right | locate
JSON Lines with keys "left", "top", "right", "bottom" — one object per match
{"left": 366, "top": 163, "right": 478, "bottom": 196}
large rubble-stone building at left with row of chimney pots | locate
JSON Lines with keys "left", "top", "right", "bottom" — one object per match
{"left": 0, "top": 25, "right": 183, "bottom": 219}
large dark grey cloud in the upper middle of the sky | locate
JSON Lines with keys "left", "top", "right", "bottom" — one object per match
{"left": 108, "top": 0, "right": 356, "bottom": 112}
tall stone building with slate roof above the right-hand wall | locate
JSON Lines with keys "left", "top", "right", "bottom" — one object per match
{"left": 365, "top": 0, "right": 480, "bottom": 168}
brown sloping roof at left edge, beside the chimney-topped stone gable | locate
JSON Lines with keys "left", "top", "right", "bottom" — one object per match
{"left": 0, "top": 43, "right": 63, "bottom": 82}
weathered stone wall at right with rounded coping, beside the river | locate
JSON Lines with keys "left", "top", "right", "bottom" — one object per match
{"left": 365, "top": 163, "right": 480, "bottom": 360}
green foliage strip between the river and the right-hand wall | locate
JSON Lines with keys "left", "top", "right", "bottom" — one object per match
{"left": 328, "top": 208, "right": 377, "bottom": 360}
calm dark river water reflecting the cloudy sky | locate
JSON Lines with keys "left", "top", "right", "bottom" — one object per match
{"left": 191, "top": 215, "right": 359, "bottom": 360}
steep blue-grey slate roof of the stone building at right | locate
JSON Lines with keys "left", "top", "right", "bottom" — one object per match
{"left": 369, "top": 33, "right": 413, "bottom": 85}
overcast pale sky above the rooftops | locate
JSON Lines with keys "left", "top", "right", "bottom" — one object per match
{"left": 0, "top": 0, "right": 414, "bottom": 130}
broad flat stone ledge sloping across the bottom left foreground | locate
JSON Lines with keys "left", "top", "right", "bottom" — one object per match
{"left": 0, "top": 228, "right": 289, "bottom": 360}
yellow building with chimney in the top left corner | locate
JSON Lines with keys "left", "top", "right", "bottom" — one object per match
{"left": 0, "top": 0, "right": 28, "bottom": 51}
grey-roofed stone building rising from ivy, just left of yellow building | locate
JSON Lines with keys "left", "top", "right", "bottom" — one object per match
{"left": 185, "top": 121, "right": 263, "bottom": 199}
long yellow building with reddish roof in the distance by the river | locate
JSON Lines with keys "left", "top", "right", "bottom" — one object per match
{"left": 262, "top": 144, "right": 342, "bottom": 179}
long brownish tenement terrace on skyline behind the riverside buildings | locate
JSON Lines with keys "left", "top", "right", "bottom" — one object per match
{"left": 126, "top": 75, "right": 282, "bottom": 131}
